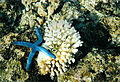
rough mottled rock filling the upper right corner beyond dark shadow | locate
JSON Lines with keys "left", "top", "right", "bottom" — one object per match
{"left": 79, "top": 0, "right": 120, "bottom": 46}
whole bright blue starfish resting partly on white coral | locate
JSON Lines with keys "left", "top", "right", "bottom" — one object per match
{"left": 13, "top": 26, "right": 56, "bottom": 70}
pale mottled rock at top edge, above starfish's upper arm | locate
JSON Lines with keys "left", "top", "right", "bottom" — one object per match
{"left": 19, "top": 0, "right": 60, "bottom": 28}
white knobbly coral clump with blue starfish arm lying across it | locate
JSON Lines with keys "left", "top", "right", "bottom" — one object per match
{"left": 36, "top": 20, "right": 83, "bottom": 79}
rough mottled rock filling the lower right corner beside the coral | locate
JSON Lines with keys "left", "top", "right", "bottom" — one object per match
{"left": 58, "top": 49, "right": 120, "bottom": 82}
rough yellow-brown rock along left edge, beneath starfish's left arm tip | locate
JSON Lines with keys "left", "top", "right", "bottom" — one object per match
{"left": 0, "top": 33, "right": 28, "bottom": 82}
